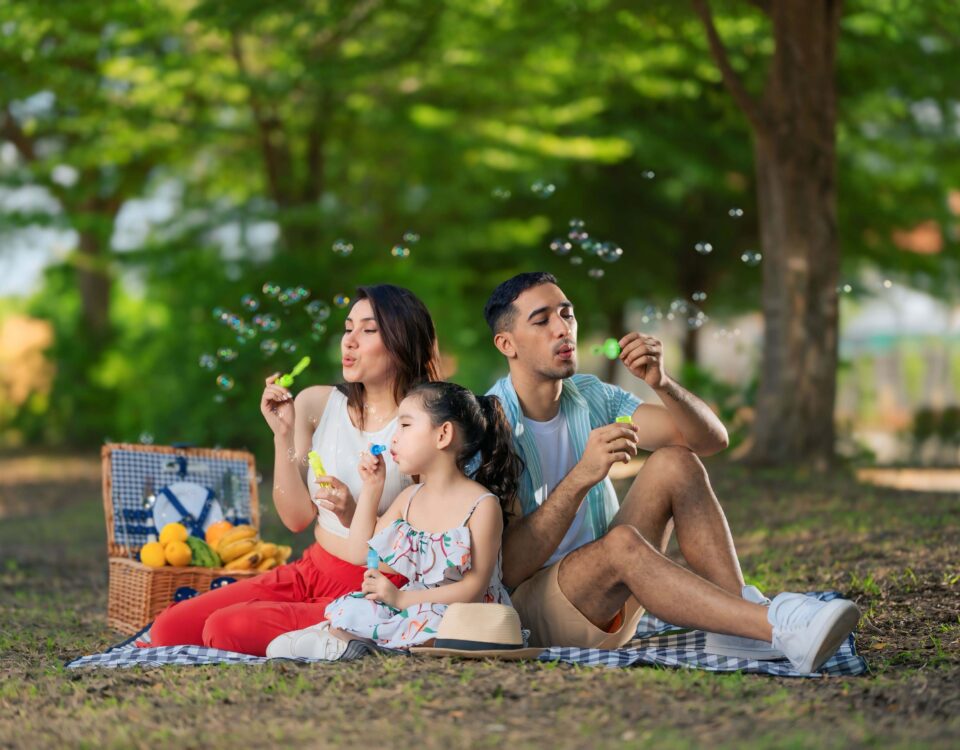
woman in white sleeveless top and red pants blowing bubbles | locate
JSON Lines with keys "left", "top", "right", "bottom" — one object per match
{"left": 149, "top": 284, "right": 440, "bottom": 656}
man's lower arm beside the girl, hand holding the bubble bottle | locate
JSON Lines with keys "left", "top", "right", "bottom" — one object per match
{"left": 503, "top": 424, "right": 637, "bottom": 588}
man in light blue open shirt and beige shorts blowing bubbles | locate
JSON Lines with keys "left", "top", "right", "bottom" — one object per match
{"left": 484, "top": 273, "right": 859, "bottom": 672}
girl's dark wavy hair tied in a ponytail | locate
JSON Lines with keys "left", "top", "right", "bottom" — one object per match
{"left": 407, "top": 382, "right": 523, "bottom": 508}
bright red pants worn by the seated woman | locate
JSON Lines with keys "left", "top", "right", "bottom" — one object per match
{"left": 137, "top": 544, "right": 407, "bottom": 656}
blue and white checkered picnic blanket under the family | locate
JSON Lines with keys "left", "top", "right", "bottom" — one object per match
{"left": 67, "top": 591, "right": 867, "bottom": 677}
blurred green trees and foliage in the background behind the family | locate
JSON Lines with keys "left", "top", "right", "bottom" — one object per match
{"left": 0, "top": 0, "right": 960, "bottom": 463}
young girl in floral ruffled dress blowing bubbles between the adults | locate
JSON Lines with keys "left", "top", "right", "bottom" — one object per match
{"left": 267, "top": 383, "right": 521, "bottom": 660}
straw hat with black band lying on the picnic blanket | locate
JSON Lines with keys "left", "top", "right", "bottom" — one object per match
{"left": 410, "top": 602, "right": 543, "bottom": 659}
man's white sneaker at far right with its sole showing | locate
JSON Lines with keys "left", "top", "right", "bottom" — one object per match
{"left": 767, "top": 593, "right": 860, "bottom": 673}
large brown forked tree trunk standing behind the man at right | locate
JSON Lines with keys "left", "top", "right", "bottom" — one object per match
{"left": 694, "top": 0, "right": 841, "bottom": 468}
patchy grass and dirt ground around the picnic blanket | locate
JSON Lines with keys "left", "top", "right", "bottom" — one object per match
{"left": 0, "top": 456, "right": 960, "bottom": 748}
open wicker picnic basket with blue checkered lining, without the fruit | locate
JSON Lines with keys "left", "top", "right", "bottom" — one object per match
{"left": 101, "top": 443, "right": 260, "bottom": 634}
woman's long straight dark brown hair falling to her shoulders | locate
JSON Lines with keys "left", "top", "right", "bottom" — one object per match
{"left": 337, "top": 284, "right": 441, "bottom": 429}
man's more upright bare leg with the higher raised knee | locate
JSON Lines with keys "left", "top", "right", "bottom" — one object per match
{"left": 611, "top": 447, "right": 743, "bottom": 600}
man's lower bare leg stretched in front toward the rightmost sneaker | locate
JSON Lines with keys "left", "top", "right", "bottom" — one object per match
{"left": 557, "top": 524, "right": 773, "bottom": 643}
